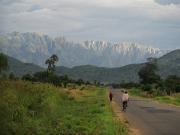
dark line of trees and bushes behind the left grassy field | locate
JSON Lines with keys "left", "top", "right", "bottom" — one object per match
{"left": 0, "top": 53, "right": 91, "bottom": 87}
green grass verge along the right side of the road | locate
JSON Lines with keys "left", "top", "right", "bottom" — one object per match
{"left": 129, "top": 88, "right": 180, "bottom": 106}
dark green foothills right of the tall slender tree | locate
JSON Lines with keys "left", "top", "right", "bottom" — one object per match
{"left": 57, "top": 50, "right": 180, "bottom": 83}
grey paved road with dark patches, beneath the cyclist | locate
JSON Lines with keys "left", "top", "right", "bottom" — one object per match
{"left": 111, "top": 89, "right": 180, "bottom": 135}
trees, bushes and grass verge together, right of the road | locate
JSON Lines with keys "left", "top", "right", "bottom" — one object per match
{"left": 113, "top": 58, "right": 180, "bottom": 105}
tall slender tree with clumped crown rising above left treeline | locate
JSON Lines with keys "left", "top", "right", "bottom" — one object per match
{"left": 45, "top": 54, "right": 59, "bottom": 73}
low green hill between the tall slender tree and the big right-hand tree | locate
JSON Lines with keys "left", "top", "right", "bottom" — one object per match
{"left": 56, "top": 64, "right": 142, "bottom": 83}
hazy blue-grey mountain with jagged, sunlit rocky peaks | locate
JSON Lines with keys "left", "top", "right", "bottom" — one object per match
{"left": 0, "top": 32, "right": 166, "bottom": 67}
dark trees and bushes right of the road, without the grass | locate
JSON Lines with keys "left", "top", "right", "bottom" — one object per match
{"left": 112, "top": 58, "right": 180, "bottom": 96}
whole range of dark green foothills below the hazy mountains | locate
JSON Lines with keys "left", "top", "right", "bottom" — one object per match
{"left": 3, "top": 49, "right": 180, "bottom": 83}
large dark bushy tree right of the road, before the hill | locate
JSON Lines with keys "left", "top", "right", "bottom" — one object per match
{"left": 138, "top": 58, "right": 160, "bottom": 84}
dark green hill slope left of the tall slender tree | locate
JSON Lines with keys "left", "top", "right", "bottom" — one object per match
{"left": 4, "top": 56, "right": 44, "bottom": 76}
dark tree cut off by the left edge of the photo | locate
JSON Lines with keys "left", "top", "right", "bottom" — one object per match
{"left": 0, "top": 53, "right": 8, "bottom": 73}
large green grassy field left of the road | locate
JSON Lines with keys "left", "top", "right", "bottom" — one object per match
{"left": 0, "top": 81, "right": 127, "bottom": 135}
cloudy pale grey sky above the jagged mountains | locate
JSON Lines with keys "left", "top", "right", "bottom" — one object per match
{"left": 0, "top": 0, "right": 180, "bottom": 49}
